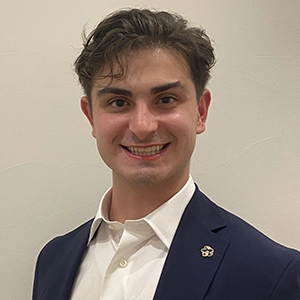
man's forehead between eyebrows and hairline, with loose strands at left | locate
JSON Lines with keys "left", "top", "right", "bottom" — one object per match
{"left": 93, "top": 49, "right": 192, "bottom": 88}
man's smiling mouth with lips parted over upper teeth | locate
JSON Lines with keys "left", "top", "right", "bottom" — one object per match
{"left": 121, "top": 143, "right": 170, "bottom": 159}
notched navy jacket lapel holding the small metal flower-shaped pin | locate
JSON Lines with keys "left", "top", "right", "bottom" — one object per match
{"left": 154, "top": 189, "right": 229, "bottom": 300}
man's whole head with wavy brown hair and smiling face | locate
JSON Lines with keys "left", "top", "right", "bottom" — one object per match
{"left": 76, "top": 9, "right": 214, "bottom": 190}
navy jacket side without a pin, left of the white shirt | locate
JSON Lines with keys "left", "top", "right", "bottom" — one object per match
{"left": 32, "top": 220, "right": 93, "bottom": 300}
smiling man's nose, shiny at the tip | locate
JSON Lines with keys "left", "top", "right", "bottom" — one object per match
{"left": 129, "top": 103, "right": 158, "bottom": 141}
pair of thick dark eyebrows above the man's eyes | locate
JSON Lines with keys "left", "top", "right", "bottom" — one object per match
{"left": 97, "top": 81, "right": 186, "bottom": 97}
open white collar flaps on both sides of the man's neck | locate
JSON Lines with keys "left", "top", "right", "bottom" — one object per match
{"left": 88, "top": 175, "right": 196, "bottom": 249}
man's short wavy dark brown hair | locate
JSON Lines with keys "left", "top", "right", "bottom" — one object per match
{"left": 75, "top": 9, "right": 215, "bottom": 106}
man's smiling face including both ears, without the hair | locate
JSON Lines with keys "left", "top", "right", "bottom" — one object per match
{"left": 81, "top": 49, "right": 210, "bottom": 186}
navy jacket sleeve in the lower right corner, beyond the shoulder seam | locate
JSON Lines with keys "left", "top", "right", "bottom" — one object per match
{"left": 271, "top": 253, "right": 300, "bottom": 300}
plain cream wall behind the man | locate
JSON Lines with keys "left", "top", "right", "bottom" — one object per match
{"left": 0, "top": 0, "right": 300, "bottom": 300}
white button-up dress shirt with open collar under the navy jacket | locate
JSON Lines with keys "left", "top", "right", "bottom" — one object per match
{"left": 71, "top": 176, "right": 195, "bottom": 300}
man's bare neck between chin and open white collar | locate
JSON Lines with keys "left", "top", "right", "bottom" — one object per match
{"left": 109, "top": 174, "right": 189, "bottom": 223}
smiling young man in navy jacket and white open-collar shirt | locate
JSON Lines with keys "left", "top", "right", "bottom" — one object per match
{"left": 33, "top": 9, "right": 300, "bottom": 300}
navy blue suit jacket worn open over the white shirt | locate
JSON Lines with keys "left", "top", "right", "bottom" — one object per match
{"left": 33, "top": 189, "right": 300, "bottom": 300}
